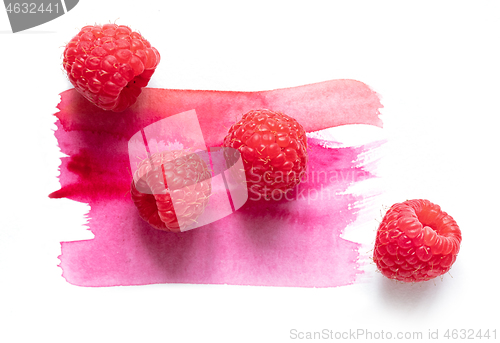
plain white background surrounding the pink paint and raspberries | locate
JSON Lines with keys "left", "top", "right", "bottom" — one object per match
{"left": 0, "top": 0, "right": 500, "bottom": 342}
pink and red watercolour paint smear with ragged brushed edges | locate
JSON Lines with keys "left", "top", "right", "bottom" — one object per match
{"left": 50, "top": 80, "right": 382, "bottom": 287}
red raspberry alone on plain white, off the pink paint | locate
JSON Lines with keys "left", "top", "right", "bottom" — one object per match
{"left": 373, "top": 199, "right": 462, "bottom": 282}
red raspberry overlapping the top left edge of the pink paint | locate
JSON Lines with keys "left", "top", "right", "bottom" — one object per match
{"left": 63, "top": 24, "right": 160, "bottom": 112}
